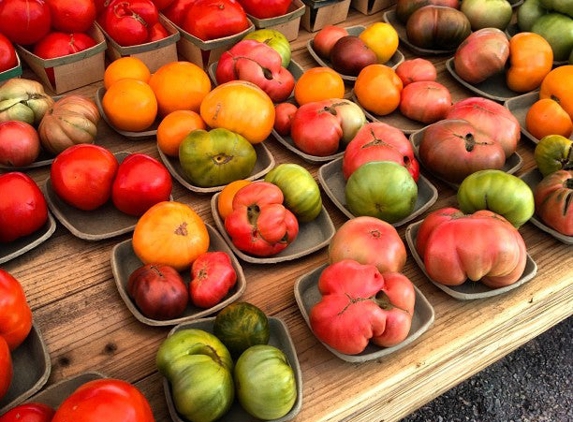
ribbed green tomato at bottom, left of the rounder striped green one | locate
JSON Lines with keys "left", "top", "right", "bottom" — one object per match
{"left": 156, "top": 329, "right": 235, "bottom": 422}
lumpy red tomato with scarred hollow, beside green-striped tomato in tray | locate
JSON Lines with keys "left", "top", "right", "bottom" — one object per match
{"left": 225, "top": 181, "right": 299, "bottom": 257}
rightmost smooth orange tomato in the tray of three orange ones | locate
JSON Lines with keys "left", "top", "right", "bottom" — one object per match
{"left": 149, "top": 61, "right": 211, "bottom": 117}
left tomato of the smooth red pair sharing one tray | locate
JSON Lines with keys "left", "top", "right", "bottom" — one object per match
{"left": 50, "top": 144, "right": 119, "bottom": 211}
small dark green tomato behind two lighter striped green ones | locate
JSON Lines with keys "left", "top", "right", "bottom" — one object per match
{"left": 213, "top": 302, "right": 271, "bottom": 356}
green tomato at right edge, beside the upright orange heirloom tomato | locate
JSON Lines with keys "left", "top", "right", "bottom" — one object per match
{"left": 531, "top": 12, "right": 573, "bottom": 62}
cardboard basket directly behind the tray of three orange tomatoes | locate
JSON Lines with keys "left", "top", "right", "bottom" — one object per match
{"left": 96, "top": 14, "right": 181, "bottom": 73}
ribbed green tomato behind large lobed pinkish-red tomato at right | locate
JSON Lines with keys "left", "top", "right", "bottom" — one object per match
{"left": 457, "top": 169, "right": 535, "bottom": 228}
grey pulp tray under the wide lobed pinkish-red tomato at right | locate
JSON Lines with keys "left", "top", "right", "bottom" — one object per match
{"left": 405, "top": 221, "right": 537, "bottom": 300}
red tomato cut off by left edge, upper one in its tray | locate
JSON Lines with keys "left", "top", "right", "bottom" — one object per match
{"left": 0, "top": 268, "right": 32, "bottom": 350}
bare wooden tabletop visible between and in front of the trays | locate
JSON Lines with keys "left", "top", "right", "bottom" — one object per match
{"left": 3, "top": 8, "right": 573, "bottom": 422}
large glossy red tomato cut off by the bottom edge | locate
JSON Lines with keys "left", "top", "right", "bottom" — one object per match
{"left": 52, "top": 378, "right": 155, "bottom": 422}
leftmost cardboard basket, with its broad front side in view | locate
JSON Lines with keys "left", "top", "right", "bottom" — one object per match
{"left": 16, "top": 24, "right": 107, "bottom": 94}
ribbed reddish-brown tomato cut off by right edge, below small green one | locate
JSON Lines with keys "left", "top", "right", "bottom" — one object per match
{"left": 534, "top": 170, "right": 573, "bottom": 236}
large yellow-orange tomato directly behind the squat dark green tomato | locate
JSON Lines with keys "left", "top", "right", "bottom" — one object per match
{"left": 200, "top": 81, "right": 275, "bottom": 144}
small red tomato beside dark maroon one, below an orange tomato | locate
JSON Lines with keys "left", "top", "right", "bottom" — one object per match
{"left": 189, "top": 251, "right": 237, "bottom": 309}
